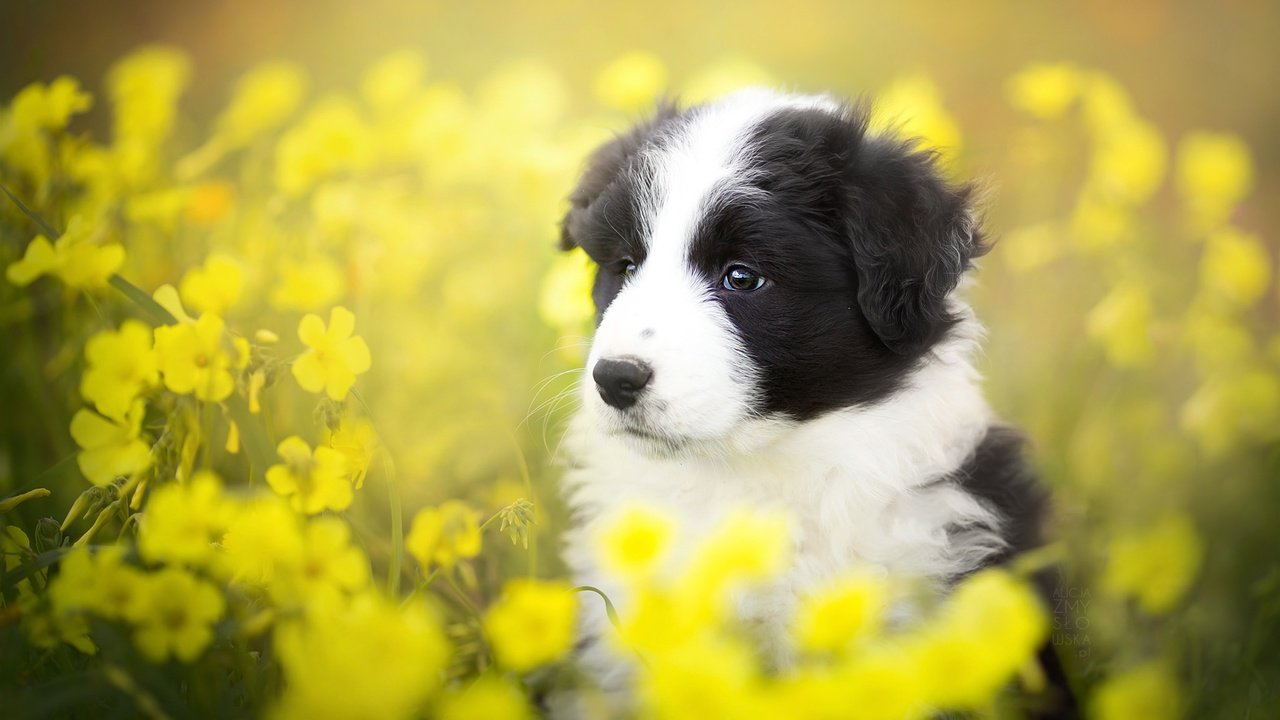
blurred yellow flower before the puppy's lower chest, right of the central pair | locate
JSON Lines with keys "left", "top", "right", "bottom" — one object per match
{"left": 795, "top": 574, "right": 888, "bottom": 652}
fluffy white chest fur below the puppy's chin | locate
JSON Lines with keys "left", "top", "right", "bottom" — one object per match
{"left": 564, "top": 333, "right": 1002, "bottom": 676}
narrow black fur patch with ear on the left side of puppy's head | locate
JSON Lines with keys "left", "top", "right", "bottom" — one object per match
{"left": 561, "top": 104, "right": 680, "bottom": 319}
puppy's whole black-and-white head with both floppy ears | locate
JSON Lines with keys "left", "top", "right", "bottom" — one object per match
{"left": 562, "top": 91, "right": 980, "bottom": 455}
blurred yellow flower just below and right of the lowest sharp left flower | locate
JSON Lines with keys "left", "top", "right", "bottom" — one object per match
{"left": 138, "top": 470, "right": 234, "bottom": 565}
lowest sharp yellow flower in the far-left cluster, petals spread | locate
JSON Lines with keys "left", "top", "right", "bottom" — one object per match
{"left": 72, "top": 400, "right": 151, "bottom": 486}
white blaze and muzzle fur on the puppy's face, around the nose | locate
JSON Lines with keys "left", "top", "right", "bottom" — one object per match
{"left": 585, "top": 90, "right": 838, "bottom": 454}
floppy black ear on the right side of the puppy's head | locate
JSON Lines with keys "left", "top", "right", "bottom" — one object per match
{"left": 846, "top": 135, "right": 986, "bottom": 356}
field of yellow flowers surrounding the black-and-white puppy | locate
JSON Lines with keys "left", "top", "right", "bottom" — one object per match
{"left": 0, "top": 7, "right": 1280, "bottom": 720}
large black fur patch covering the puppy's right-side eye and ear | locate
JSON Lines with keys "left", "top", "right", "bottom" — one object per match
{"left": 690, "top": 101, "right": 978, "bottom": 420}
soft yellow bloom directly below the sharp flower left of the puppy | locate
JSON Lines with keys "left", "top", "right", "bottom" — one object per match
{"left": 268, "top": 518, "right": 369, "bottom": 605}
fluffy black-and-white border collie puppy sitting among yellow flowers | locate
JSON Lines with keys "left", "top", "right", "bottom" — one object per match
{"left": 562, "top": 90, "right": 1064, "bottom": 707}
